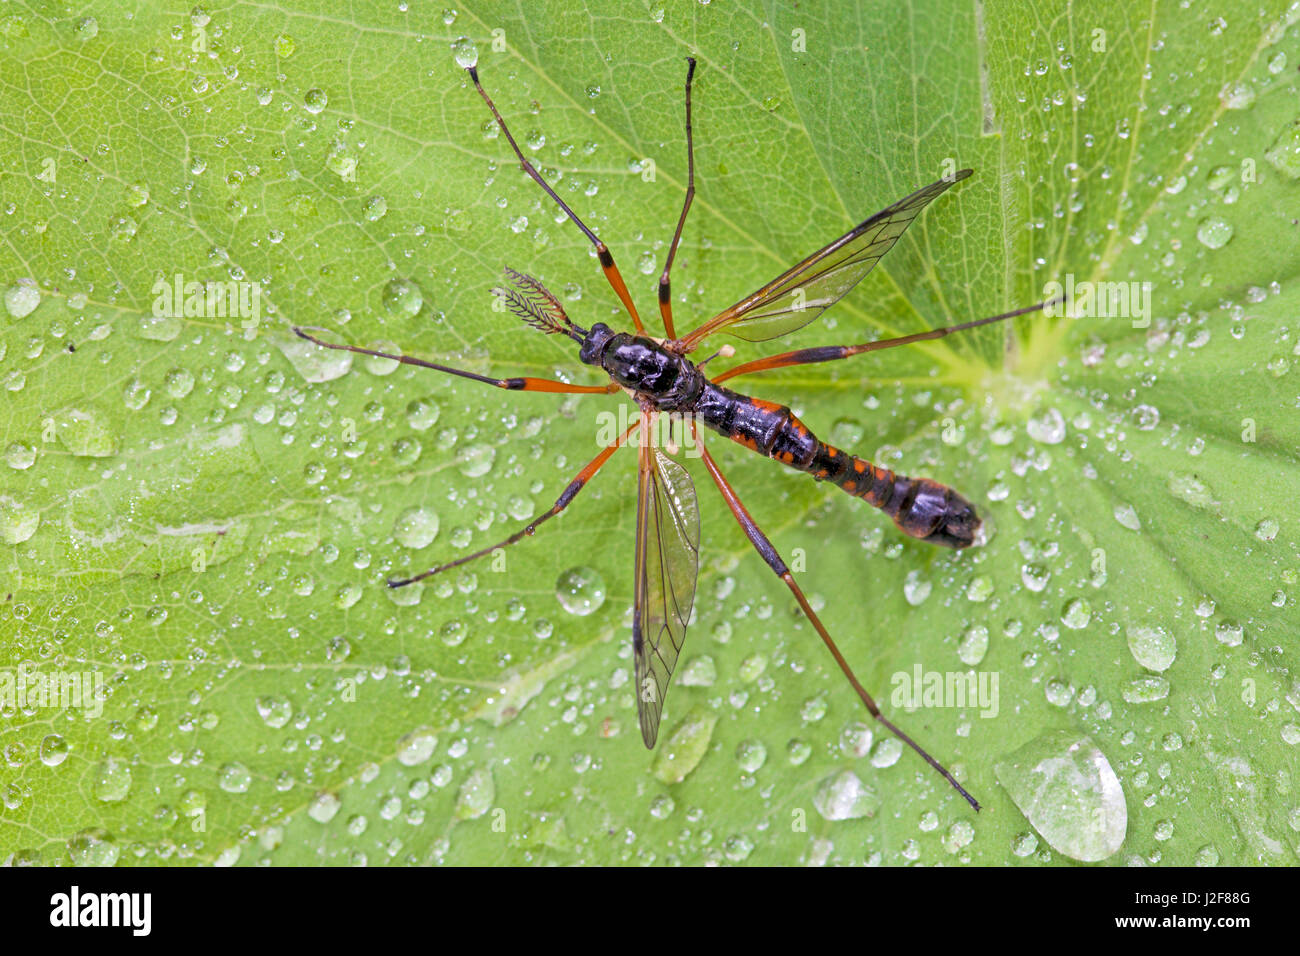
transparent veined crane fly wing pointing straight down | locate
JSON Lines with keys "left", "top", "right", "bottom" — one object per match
{"left": 632, "top": 415, "right": 699, "bottom": 748}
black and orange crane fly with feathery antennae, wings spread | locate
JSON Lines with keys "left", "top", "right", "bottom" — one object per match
{"left": 294, "top": 57, "right": 1045, "bottom": 810}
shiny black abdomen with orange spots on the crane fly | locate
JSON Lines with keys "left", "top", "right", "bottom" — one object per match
{"left": 696, "top": 382, "right": 979, "bottom": 548}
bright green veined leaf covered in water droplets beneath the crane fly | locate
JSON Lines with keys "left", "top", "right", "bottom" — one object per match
{"left": 0, "top": 0, "right": 1300, "bottom": 864}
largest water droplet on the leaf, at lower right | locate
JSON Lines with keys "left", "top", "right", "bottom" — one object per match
{"left": 995, "top": 730, "right": 1128, "bottom": 862}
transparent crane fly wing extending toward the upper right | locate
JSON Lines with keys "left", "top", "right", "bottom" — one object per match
{"left": 685, "top": 169, "right": 971, "bottom": 347}
